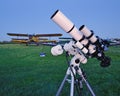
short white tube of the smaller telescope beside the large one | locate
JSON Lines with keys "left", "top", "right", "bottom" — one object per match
{"left": 79, "top": 25, "right": 97, "bottom": 43}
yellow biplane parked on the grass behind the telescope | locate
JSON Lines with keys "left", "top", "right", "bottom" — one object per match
{"left": 7, "top": 33, "right": 62, "bottom": 45}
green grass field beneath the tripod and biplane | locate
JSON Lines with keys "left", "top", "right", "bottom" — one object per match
{"left": 0, "top": 44, "right": 120, "bottom": 96}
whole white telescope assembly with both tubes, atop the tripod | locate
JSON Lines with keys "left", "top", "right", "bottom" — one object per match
{"left": 51, "top": 10, "right": 110, "bottom": 67}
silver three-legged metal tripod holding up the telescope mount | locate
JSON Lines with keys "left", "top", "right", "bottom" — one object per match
{"left": 56, "top": 53, "right": 96, "bottom": 96}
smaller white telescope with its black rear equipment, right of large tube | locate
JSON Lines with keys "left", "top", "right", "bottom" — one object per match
{"left": 79, "top": 25, "right": 110, "bottom": 67}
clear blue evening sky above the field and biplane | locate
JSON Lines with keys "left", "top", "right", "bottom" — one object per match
{"left": 0, "top": 0, "right": 120, "bottom": 41}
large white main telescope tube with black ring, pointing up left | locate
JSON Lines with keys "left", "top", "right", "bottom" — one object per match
{"left": 51, "top": 10, "right": 83, "bottom": 41}
